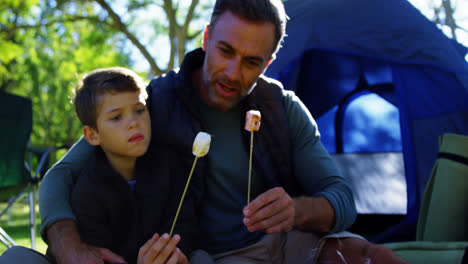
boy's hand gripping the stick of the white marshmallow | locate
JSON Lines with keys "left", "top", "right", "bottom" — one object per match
{"left": 138, "top": 233, "right": 188, "bottom": 264}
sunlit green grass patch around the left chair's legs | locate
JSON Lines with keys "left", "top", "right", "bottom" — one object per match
{"left": 0, "top": 196, "right": 47, "bottom": 255}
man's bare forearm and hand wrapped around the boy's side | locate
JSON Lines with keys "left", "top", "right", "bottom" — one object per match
{"left": 47, "top": 220, "right": 125, "bottom": 264}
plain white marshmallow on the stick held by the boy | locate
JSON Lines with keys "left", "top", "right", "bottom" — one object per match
{"left": 169, "top": 132, "right": 211, "bottom": 237}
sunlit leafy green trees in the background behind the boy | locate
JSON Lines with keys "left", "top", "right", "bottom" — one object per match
{"left": 0, "top": 0, "right": 212, "bottom": 160}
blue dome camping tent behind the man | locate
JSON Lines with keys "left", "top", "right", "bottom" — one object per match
{"left": 266, "top": 0, "right": 468, "bottom": 241}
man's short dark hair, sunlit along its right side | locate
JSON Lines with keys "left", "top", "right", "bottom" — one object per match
{"left": 209, "top": 0, "right": 287, "bottom": 56}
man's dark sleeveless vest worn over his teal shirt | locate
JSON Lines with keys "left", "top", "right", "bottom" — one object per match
{"left": 148, "top": 49, "right": 303, "bottom": 202}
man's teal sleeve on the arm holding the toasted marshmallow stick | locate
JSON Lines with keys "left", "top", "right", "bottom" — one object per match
{"left": 284, "top": 92, "right": 357, "bottom": 232}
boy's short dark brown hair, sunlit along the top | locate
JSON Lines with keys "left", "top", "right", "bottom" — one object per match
{"left": 74, "top": 67, "right": 148, "bottom": 129}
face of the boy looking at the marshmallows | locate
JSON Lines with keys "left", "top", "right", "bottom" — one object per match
{"left": 83, "top": 92, "right": 151, "bottom": 159}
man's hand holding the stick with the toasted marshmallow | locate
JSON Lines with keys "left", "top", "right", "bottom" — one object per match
{"left": 243, "top": 187, "right": 295, "bottom": 234}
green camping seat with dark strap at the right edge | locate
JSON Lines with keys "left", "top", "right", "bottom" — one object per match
{"left": 385, "top": 133, "right": 468, "bottom": 264}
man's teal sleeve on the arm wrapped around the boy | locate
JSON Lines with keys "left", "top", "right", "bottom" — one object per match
{"left": 39, "top": 137, "right": 93, "bottom": 242}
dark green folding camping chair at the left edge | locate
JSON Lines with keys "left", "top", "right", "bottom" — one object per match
{"left": 0, "top": 91, "right": 63, "bottom": 248}
